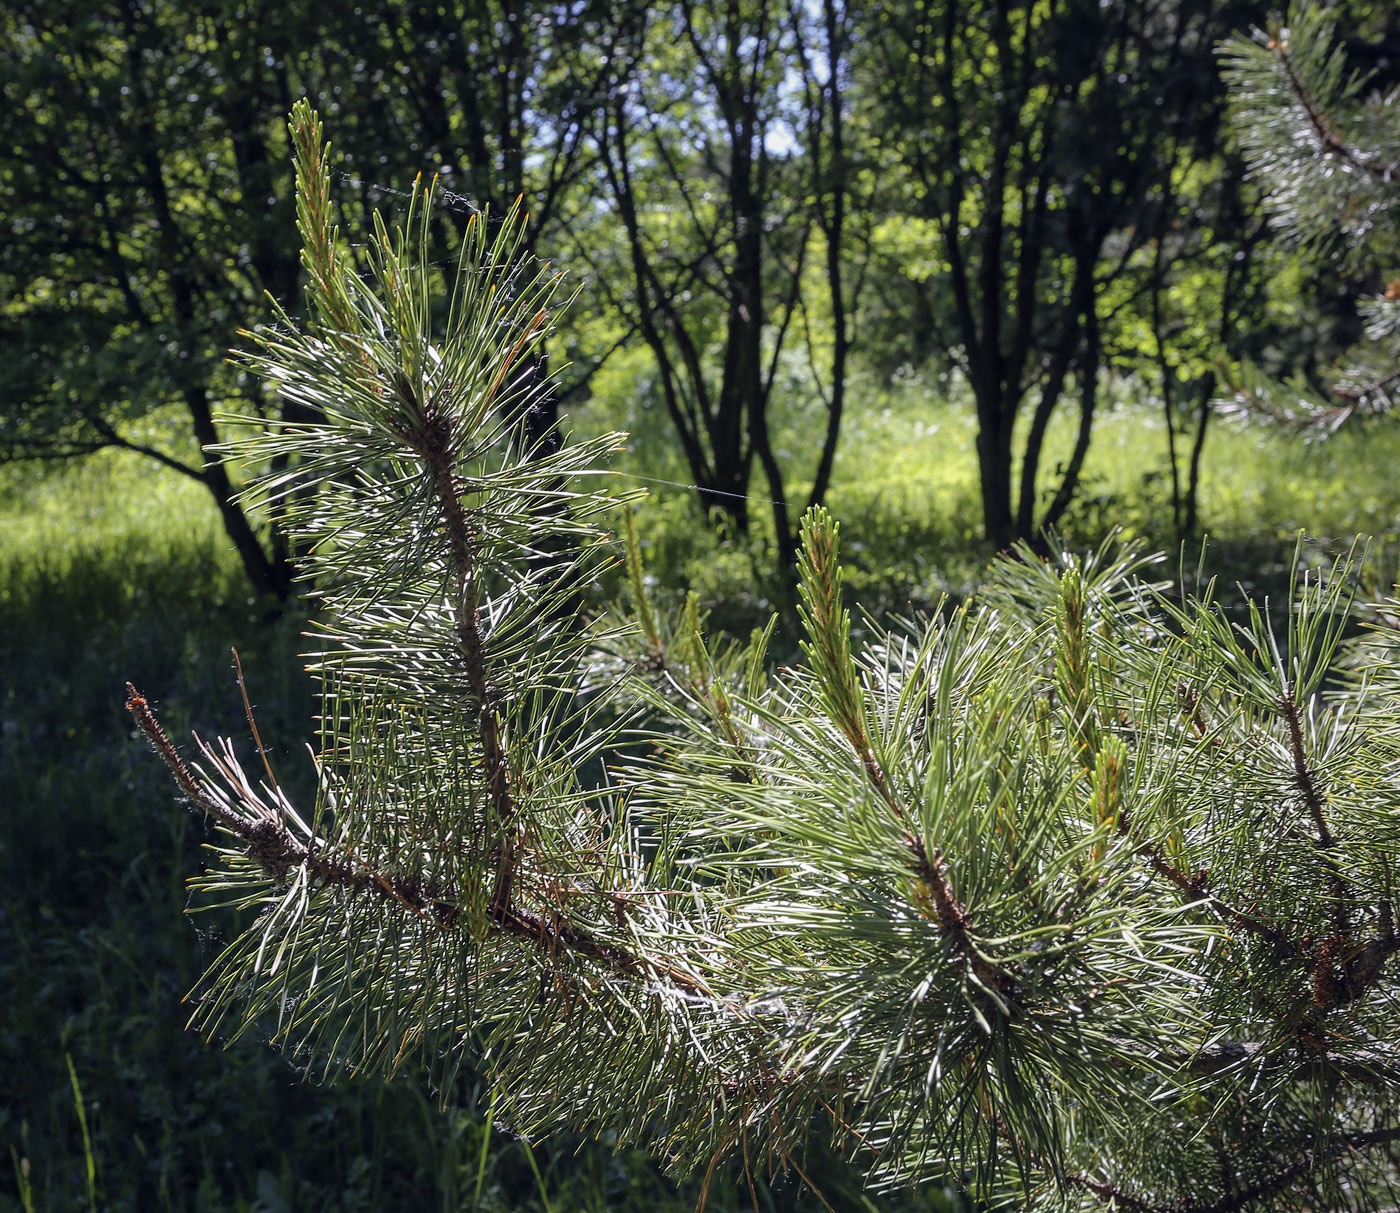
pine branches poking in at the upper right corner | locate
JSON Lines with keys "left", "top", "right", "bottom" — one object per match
{"left": 1221, "top": 0, "right": 1400, "bottom": 434}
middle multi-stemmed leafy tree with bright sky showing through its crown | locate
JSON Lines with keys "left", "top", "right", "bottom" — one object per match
{"left": 580, "top": 0, "right": 857, "bottom": 566}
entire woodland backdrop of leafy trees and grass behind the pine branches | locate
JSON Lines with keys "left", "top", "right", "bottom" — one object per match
{"left": 8, "top": 0, "right": 1400, "bottom": 1210}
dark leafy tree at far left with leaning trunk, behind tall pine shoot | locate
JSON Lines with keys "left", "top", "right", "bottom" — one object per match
{"left": 0, "top": 0, "right": 629, "bottom": 597}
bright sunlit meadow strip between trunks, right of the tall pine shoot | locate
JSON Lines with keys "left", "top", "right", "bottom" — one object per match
{"left": 571, "top": 375, "right": 1400, "bottom": 632}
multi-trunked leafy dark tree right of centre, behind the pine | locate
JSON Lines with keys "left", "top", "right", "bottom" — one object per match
{"left": 868, "top": 0, "right": 1265, "bottom": 548}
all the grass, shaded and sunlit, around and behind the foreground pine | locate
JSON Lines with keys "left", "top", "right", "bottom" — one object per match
{"left": 10, "top": 381, "right": 1400, "bottom": 1213}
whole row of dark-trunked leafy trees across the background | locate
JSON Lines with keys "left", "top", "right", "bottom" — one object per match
{"left": 0, "top": 0, "right": 1332, "bottom": 585}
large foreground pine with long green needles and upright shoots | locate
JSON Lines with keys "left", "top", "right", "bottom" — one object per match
{"left": 130, "top": 105, "right": 1400, "bottom": 1213}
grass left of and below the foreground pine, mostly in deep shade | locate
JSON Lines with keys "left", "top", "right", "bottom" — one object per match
{"left": 0, "top": 448, "right": 630, "bottom": 1210}
